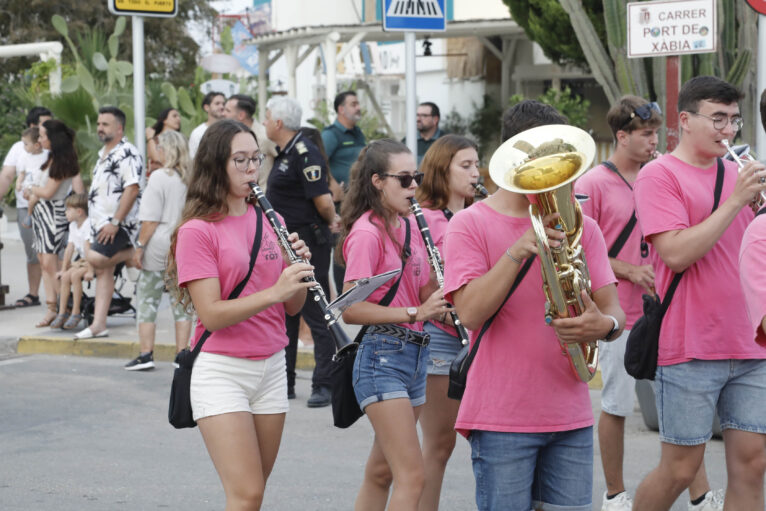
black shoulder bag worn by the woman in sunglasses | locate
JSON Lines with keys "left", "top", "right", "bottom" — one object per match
{"left": 330, "top": 220, "right": 410, "bottom": 429}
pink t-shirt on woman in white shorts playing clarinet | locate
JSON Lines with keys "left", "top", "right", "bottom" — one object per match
{"left": 176, "top": 207, "right": 287, "bottom": 360}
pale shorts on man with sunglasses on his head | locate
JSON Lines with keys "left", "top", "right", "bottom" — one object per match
{"left": 598, "top": 330, "right": 636, "bottom": 417}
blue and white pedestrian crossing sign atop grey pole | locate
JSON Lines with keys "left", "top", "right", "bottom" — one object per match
{"left": 383, "top": 0, "right": 447, "bottom": 32}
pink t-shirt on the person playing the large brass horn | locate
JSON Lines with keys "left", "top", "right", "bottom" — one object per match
{"left": 445, "top": 202, "right": 616, "bottom": 435}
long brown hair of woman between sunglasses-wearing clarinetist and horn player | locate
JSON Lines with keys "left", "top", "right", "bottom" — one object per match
{"left": 415, "top": 135, "right": 479, "bottom": 209}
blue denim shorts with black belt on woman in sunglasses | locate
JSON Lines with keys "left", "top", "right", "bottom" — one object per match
{"left": 352, "top": 333, "right": 428, "bottom": 410}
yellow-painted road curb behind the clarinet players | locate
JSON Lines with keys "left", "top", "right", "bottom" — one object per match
{"left": 16, "top": 336, "right": 314, "bottom": 369}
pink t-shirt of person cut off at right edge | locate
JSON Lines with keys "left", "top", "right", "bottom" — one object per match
{"left": 739, "top": 214, "right": 766, "bottom": 347}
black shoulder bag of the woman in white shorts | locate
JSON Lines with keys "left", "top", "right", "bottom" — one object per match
{"left": 168, "top": 206, "right": 263, "bottom": 429}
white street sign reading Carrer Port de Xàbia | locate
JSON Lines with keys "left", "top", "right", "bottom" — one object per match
{"left": 628, "top": 0, "right": 718, "bottom": 58}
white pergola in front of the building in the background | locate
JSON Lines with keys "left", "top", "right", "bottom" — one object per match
{"left": 250, "top": 19, "right": 526, "bottom": 118}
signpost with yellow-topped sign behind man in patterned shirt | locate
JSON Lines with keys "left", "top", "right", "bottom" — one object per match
{"left": 109, "top": 0, "right": 178, "bottom": 181}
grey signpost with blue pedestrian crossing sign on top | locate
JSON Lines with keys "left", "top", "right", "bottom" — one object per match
{"left": 382, "top": 0, "right": 447, "bottom": 156}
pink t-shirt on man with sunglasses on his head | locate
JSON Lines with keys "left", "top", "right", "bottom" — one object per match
{"left": 575, "top": 165, "right": 651, "bottom": 330}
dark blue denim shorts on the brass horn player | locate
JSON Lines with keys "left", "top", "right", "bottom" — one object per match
{"left": 468, "top": 426, "right": 593, "bottom": 511}
